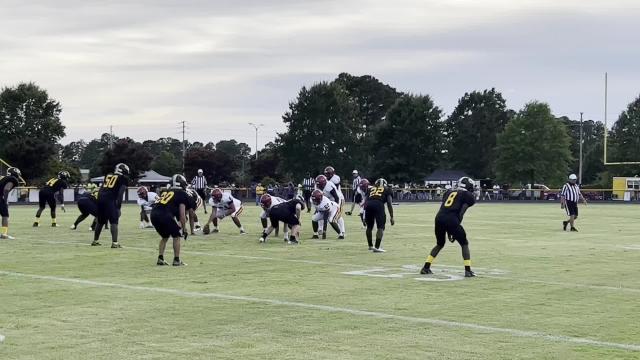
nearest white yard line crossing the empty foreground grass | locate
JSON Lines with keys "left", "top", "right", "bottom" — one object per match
{"left": 0, "top": 271, "right": 640, "bottom": 351}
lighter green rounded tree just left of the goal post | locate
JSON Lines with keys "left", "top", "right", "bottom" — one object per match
{"left": 496, "top": 101, "right": 573, "bottom": 186}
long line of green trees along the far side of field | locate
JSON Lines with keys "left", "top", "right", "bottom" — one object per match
{"left": 0, "top": 78, "right": 640, "bottom": 187}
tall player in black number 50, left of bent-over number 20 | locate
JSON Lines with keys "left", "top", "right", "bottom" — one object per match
{"left": 91, "top": 163, "right": 130, "bottom": 249}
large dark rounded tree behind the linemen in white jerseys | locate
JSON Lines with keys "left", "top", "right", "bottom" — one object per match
{"left": 279, "top": 82, "right": 359, "bottom": 178}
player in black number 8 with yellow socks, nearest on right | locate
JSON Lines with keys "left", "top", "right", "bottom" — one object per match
{"left": 420, "top": 177, "right": 476, "bottom": 277}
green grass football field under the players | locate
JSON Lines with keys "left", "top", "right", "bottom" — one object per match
{"left": 0, "top": 203, "right": 640, "bottom": 359}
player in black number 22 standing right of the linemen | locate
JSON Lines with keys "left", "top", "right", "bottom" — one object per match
{"left": 361, "top": 179, "right": 395, "bottom": 253}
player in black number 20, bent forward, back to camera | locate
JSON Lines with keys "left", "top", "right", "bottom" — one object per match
{"left": 151, "top": 174, "right": 190, "bottom": 266}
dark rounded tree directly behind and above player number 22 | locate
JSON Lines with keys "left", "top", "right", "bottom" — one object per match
{"left": 370, "top": 95, "right": 443, "bottom": 181}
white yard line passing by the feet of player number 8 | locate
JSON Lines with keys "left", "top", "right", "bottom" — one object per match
{"left": 18, "top": 240, "right": 640, "bottom": 294}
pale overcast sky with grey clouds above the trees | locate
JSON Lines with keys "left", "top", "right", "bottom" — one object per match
{"left": 0, "top": 0, "right": 640, "bottom": 148}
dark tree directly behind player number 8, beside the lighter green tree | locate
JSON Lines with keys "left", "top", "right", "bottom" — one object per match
{"left": 445, "top": 89, "right": 513, "bottom": 179}
